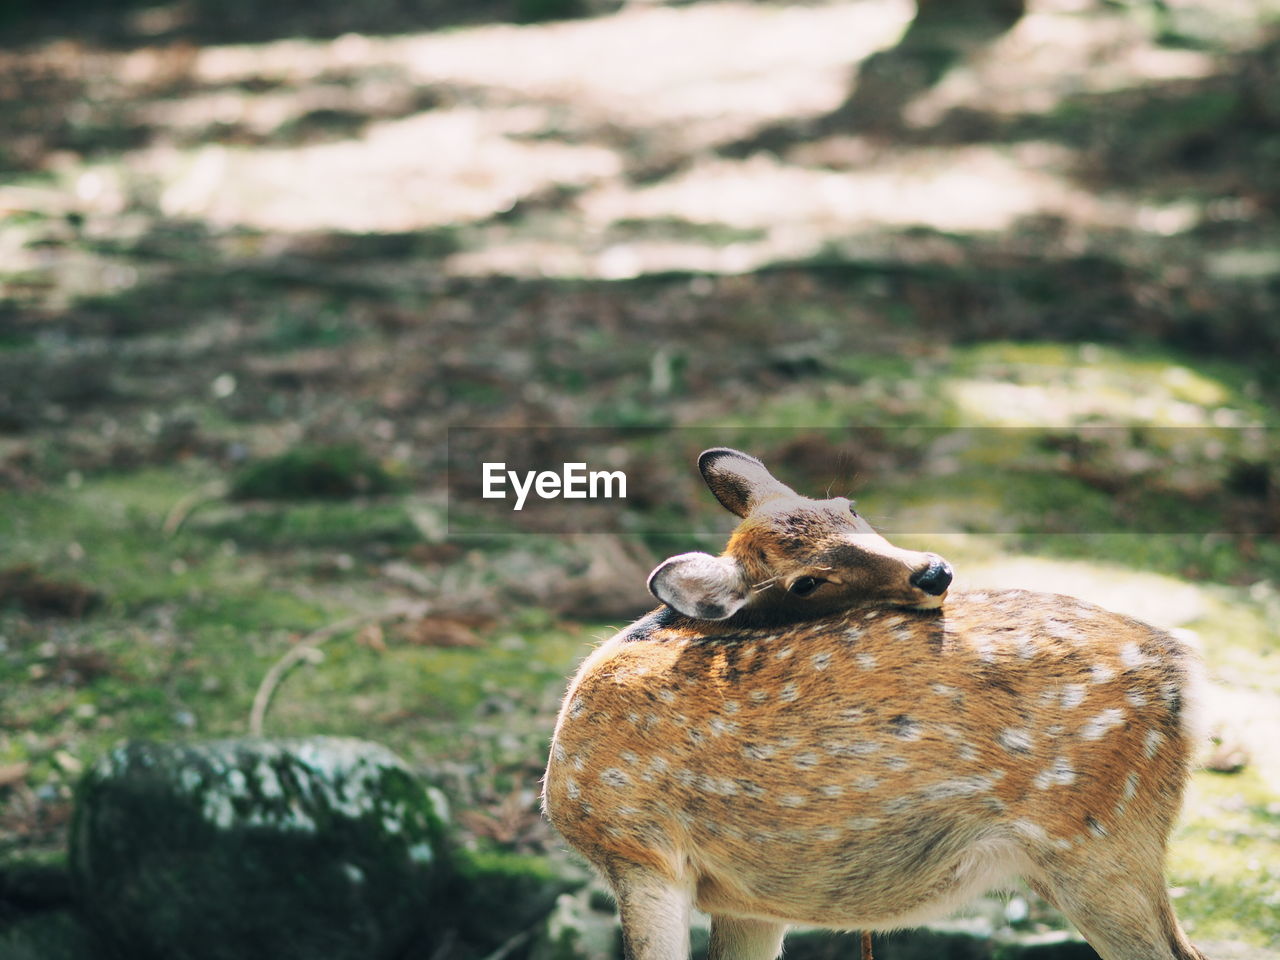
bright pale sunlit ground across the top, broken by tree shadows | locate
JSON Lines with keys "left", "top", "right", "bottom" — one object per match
{"left": 0, "top": 0, "right": 1277, "bottom": 289}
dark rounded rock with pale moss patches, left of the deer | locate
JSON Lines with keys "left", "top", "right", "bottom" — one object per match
{"left": 70, "top": 737, "right": 452, "bottom": 960}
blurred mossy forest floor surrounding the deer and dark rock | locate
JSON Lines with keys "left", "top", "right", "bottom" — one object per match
{"left": 0, "top": 0, "right": 1280, "bottom": 956}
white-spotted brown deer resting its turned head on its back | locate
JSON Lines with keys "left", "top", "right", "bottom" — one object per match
{"left": 544, "top": 449, "right": 1203, "bottom": 960}
